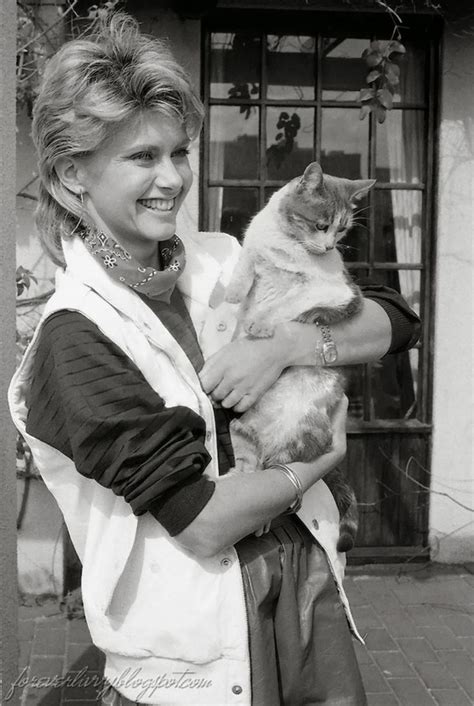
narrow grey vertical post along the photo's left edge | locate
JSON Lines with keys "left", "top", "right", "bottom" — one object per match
{"left": 0, "top": 0, "right": 18, "bottom": 704}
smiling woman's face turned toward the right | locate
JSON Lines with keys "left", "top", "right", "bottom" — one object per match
{"left": 77, "top": 112, "right": 192, "bottom": 265}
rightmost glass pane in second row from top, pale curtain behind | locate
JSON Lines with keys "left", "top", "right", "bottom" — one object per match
{"left": 375, "top": 110, "right": 425, "bottom": 184}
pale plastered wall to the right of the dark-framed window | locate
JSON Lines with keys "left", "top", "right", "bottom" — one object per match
{"left": 430, "top": 26, "right": 474, "bottom": 562}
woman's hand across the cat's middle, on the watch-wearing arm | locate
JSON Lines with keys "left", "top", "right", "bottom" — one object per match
{"left": 199, "top": 328, "right": 291, "bottom": 412}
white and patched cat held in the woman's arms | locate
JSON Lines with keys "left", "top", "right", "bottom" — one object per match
{"left": 225, "top": 162, "right": 375, "bottom": 551}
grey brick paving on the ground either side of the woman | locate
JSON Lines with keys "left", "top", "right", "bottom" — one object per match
{"left": 7, "top": 564, "right": 474, "bottom": 706}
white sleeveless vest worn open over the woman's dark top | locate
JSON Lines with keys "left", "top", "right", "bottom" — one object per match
{"left": 9, "top": 228, "right": 361, "bottom": 706}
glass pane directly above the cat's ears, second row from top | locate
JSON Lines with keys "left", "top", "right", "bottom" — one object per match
{"left": 321, "top": 108, "right": 369, "bottom": 179}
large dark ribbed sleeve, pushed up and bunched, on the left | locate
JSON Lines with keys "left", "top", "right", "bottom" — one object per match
{"left": 26, "top": 311, "right": 215, "bottom": 536}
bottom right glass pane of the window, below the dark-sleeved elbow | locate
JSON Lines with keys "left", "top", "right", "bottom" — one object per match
{"left": 371, "top": 349, "right": 419, "bottom": 419}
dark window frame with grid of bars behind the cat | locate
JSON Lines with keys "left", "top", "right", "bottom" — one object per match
{"left": 199, "top": 10, "right": 442, "bottom": 434}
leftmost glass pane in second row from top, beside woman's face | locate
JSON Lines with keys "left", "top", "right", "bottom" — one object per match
{"left": 209, "top": 105, "right": 259, "bottom": 180}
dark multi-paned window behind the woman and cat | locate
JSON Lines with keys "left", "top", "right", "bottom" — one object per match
{"left": 202, "top": 20, "right": 433, "bottom": 426}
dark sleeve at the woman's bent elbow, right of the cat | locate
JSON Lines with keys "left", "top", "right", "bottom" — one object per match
{"left": 357, "top": 279, "right": 420, "bottom": 353}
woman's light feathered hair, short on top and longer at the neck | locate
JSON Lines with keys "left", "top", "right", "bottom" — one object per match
{"left": 32, "top": 13, "right": 204, "bottom": 265}
